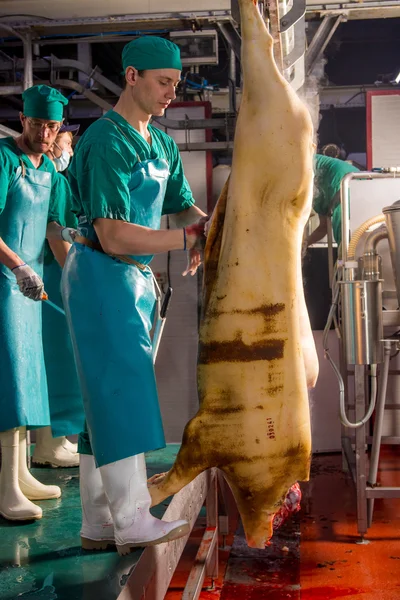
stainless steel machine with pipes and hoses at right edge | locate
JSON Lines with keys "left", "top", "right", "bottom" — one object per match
{"left": 324, "top": 168, "right": 400, "bottom": 541}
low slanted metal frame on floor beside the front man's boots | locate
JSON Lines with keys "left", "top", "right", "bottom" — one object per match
{"left": 118, "top": 468, "right": 218, "bottom": 600}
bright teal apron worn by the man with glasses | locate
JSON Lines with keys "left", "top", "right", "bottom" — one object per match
{"left": 0, "top": 160, "right": 51, "bottom": 431}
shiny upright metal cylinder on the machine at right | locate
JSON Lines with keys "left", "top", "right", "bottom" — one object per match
{"left": 340, "top": 280, "right": 383, "bottom": 365}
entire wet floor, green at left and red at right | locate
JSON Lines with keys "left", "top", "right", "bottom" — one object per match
{"left": 0, "top": 446, "right": 400, "bottom": 600}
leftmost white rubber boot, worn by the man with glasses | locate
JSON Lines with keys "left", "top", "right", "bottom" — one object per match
{"left": 0, "top": 429, "right": 43, "bottom": 521}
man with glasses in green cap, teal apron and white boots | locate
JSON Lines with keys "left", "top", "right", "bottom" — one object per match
{"left": 0, "top": 85, "right": 72, "bottom": 520}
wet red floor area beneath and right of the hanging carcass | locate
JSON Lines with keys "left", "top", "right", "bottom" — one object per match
{"left": 167, "top": 447, "right": 400, "bottom": 600}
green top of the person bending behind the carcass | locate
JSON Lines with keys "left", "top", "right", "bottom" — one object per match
{"left": 313, "top": 154, "right": 359, "bottom": 217}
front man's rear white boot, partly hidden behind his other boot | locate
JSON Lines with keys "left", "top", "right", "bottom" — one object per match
{"left": 79, "top": 454, "right": 115, "bottom": 550}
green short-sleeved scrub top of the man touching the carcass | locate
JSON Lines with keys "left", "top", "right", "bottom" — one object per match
{"left": 68, "top": 110, "right": 194, "bottom": 222}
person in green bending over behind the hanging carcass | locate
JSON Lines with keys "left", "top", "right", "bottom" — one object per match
{"left": 305, "top": 154, "right": 359, "bottom": 246}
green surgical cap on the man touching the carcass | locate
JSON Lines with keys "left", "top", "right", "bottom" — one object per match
{"left": 122, "top": 36, "right": 182, "bottom": 72}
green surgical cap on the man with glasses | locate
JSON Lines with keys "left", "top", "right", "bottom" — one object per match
{"left": 22, "top": 85, "right": 68, "bottom": 121}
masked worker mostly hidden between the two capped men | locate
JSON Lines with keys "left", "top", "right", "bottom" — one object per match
{"left": 32, "top": 125, "right": 84, "bottom": 467}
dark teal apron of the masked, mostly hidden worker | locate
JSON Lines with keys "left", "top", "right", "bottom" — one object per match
{"left": 43, "top": 259, "right": 85, "bottom": 437}
